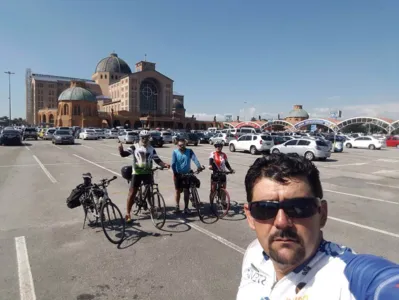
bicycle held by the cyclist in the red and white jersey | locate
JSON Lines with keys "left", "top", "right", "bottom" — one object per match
{"left": 210, "top": 171, "right": 233, "bottom": 219}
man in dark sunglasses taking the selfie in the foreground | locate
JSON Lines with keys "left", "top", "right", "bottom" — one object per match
{"left": 237, "top": 154, "right": 399, "bottom": 300}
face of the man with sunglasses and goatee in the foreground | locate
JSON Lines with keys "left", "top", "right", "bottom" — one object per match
{"left": 244, "top": 178, "right": 327, "bottom": 269}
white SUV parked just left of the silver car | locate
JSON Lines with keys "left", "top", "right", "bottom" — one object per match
{"left": 229, "top": 134, "right": 274, "bottom": 155}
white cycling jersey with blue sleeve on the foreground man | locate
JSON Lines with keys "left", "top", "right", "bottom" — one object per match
{"left": 237, "top": 240, "right": 399, "bottom": 300}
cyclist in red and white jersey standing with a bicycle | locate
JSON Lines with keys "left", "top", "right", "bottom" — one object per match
{"left": 208, "top": 141, "right": 234, "bottom": 203}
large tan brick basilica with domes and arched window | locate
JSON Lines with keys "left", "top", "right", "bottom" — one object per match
{"left": 26, "top": 53, "right": 219, "bottom": 130}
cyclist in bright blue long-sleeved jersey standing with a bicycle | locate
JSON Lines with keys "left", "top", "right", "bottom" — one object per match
{"left": 172, "top": 139, "right": 202, "bottom": 214}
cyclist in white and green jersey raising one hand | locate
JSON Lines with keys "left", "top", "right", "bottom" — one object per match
{"left": 119, "top": 130, "right": 170, "bottom": 222}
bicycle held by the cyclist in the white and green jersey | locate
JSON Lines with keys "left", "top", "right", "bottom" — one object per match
{"left": 133, "top": 167, "right": 166, "bottom": 229}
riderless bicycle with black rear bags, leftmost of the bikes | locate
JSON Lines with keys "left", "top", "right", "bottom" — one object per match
{"left": 80, "top": 173, "right": 125, "bottom": 244}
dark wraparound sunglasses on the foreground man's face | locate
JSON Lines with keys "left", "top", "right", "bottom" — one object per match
{"left": 249, "top": 197, "right": 320, "bottom": 221}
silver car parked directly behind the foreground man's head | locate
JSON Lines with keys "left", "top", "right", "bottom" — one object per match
{"left": 270, "top": 139, "right": 331, "bottom": 160}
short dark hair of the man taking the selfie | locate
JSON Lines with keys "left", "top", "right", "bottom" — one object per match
{"left": 245, "top": 153, "right": 323, "bottom": 202}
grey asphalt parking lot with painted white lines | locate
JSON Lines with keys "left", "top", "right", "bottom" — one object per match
{"left": 0, "top": 140, "right": 399, "bottom": 300}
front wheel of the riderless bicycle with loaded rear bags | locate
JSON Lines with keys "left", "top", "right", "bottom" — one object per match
{"left": 100, "top": 201, "right": 125, "bottom": 244}
